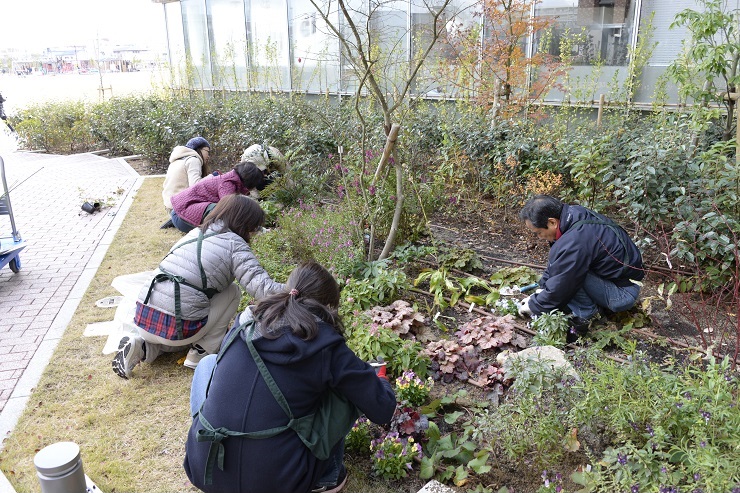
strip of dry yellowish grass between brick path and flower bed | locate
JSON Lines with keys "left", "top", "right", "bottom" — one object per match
{"left": 0, "top": 178, "right": 408, "bottom": 493}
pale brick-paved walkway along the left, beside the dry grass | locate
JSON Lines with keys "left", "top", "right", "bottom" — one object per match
{"left": 0, "top": 152, "right": 143, "bottom": 492}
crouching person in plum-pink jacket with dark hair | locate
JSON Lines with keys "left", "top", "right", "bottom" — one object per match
{"left": 170, "top": 161, "right": 265, "bottom": 233}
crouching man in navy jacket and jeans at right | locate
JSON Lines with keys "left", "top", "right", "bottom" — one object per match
{"left": 519, "top": 195, "right": 645, "bottom": 333}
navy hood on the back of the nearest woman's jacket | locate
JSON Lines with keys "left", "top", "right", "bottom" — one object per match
{"left": 236, "top": 309, "right": 344, "bottom": 365}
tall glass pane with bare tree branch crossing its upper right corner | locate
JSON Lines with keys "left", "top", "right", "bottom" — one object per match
{"left": 289, "top": 0, "right": 339, "bottom": 92}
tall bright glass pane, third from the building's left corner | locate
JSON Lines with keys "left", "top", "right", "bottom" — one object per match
{"left": 208, "top": 0, "right": 249, "bottom": 89}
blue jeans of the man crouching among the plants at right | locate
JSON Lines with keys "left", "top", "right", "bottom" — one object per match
{"left": 568, "top": 273, "right": 640, "bottom": 319}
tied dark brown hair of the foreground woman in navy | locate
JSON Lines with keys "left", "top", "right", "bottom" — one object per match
{"left": 252, "top": 262, "right": 344, "bottom": 341}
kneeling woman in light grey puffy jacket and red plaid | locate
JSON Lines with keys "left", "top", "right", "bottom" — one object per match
{"left": 112, "top": 194, "right": 285, "bottom": 378}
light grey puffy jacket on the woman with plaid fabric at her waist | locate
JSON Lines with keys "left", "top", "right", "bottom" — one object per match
{"left": 139, "top": 221, "right": 285, "bottom": 320}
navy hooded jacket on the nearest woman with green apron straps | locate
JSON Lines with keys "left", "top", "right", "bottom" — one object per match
{"left": 184, "top": 310, "right": 396, "bottom": 493}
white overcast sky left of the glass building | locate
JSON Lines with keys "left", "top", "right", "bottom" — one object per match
{"left": 0, "top": 0, "right": 166, "bottom": 50}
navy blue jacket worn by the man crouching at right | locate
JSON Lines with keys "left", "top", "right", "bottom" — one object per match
{"left": 529, "top": 205, "right": 645, "bottom": 315}
